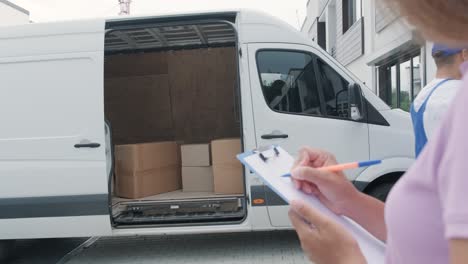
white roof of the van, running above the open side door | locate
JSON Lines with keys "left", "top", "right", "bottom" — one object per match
{"left": 0, "top": 9, "right": 314, "bottom": 45}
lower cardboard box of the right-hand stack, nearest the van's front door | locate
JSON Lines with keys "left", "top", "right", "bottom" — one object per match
{"left": 213, "top": 165, "right": 244, "bottom": 194}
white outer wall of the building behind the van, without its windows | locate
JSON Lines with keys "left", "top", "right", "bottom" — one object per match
{"left": 302, "top": 0, "right": 435, "bottom": 93}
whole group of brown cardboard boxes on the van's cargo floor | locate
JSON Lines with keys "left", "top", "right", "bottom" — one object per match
{"left": 115, "top": 138, "right": 244, "bottom": 199}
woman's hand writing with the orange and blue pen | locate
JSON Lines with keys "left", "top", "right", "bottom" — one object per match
{"left": 291, "top": 148, "right": 359, "bottom": 215}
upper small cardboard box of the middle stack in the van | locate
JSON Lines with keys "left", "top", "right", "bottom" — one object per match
{"left": 180, "top": 144, "right": 211, "bottom": 167}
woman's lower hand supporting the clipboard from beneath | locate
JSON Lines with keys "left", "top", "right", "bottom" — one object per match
{"left": 289, "top": 201, "right": 366, "bottom": 264}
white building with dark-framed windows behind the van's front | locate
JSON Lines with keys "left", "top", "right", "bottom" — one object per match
{"left": 302, "top": 0, "right": 435, "bottom": 110}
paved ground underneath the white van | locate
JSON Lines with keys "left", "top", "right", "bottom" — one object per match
{"left": 2, "top": 231, "right": 309, "bottom": 264}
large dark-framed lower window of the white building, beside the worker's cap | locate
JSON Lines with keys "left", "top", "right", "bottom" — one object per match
{"left": 378, "top": 51, "right": 422, "bottom": 111}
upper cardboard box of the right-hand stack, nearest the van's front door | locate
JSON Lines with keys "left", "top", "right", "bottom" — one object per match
{"left": 211, "top": 138, "right": 241, "bottom": 166}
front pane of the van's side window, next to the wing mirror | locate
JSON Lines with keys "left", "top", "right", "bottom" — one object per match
{"left": 317, "top": 59, "right": 349, "bottom": 118}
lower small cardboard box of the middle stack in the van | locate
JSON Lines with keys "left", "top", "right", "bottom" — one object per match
{"left": 182, "top": 167, "right": 213, "bottom": 192}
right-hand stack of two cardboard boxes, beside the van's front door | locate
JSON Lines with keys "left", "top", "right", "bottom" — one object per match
{"left": 211, "top": 138, "right": 244, "bottom": 194}
